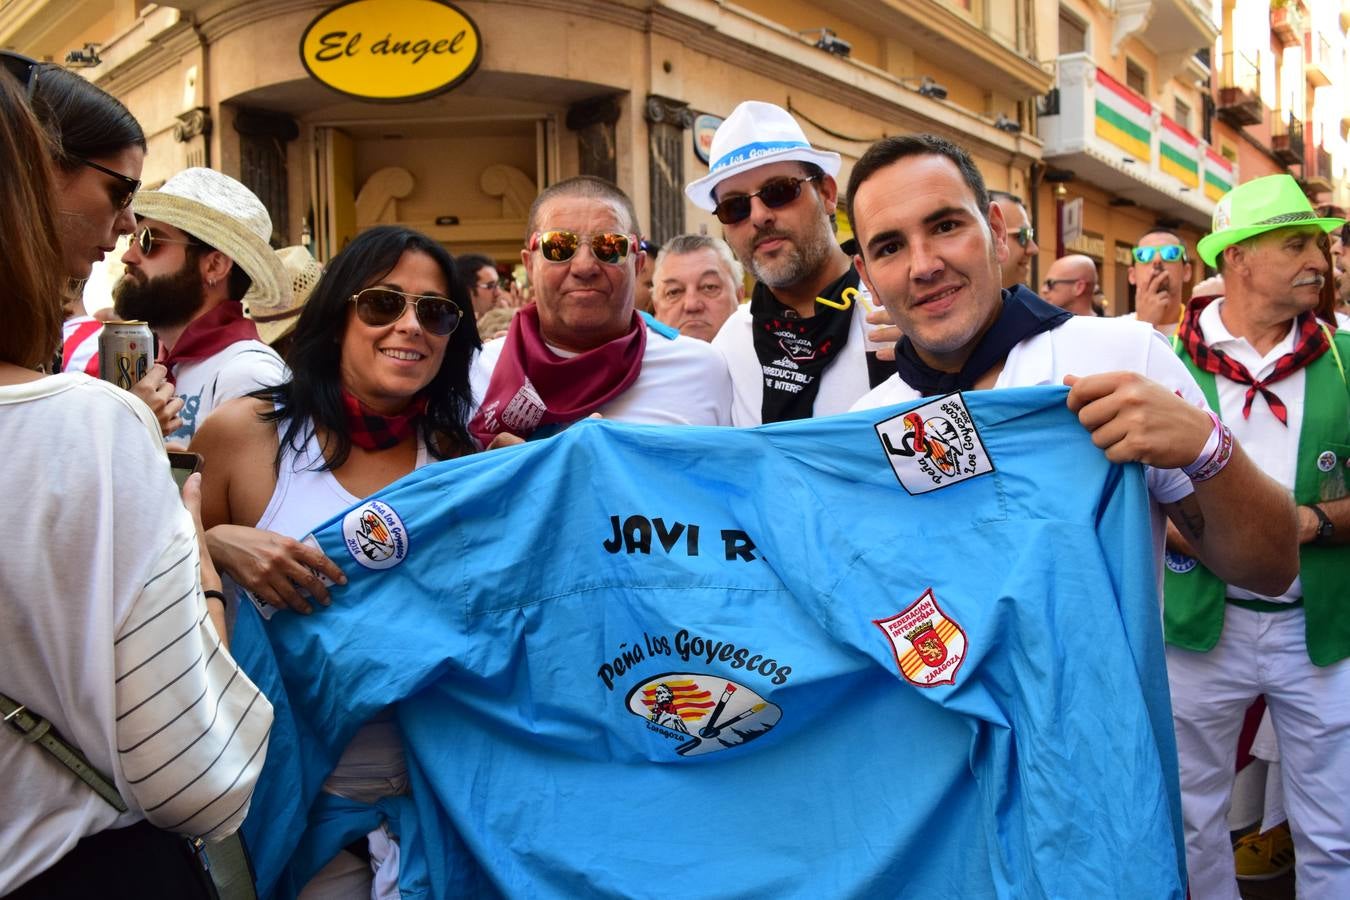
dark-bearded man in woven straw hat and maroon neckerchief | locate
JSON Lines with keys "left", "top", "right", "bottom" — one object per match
{"left": 113, "top": 169, "right": 290, "bottom": 444}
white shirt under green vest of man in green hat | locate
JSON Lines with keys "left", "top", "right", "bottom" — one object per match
{"left": 1200, "top": 298, "right": 1308, "bottom": 603}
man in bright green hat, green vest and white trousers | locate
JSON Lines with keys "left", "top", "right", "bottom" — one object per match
{"left": 1164, "top": 175, "right": 1350, "bottom": 900}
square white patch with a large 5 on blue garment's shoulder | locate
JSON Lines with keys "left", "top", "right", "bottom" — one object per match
{"left": 875, "top": 394, "right": 994, "bottom": 494}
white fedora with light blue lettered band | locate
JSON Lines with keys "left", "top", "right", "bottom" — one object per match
{"left": 684, "top": 100, "right": 840, "bottom": 212}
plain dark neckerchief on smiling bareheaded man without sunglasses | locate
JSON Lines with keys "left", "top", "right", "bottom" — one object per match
{"left": 895, "top": 285, "right": 1073, "bottom": 397}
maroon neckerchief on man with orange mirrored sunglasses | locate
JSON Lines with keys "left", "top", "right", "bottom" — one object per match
{"left": 468, "top": 304, "right": 647, "bottom": 447}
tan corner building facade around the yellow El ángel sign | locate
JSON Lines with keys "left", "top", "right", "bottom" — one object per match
{"left": 0, "top": 0, "right": 1052, "bottom": 272}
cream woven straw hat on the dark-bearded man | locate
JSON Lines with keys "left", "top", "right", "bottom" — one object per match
{"left": 131, "top": 167, "right": 290, "bottom": 310}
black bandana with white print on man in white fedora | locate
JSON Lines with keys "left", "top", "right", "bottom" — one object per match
{"left": 751, "top": 266, "right": 888, "bottom": 424}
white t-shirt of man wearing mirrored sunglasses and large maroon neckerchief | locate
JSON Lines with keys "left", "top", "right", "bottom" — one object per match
{"left": 468, "top": 318, "right": 732, "bottom": 425}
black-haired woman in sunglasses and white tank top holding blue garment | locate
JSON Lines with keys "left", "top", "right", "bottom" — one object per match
{"left": 192, "top": 225, "right": 481, "bottom": 897}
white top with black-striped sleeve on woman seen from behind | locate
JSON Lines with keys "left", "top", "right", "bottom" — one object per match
{"left": 0, "top": 372, "right": 271, "bottom": 895}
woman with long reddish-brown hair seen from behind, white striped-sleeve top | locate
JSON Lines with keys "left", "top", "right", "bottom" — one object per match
{"left": 0, "top": 65, "right": 271, "bottom": 899}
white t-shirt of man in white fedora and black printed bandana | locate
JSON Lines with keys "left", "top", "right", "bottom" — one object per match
{"left": 713, "top": 285, "right": 876, "bottom": 428}
